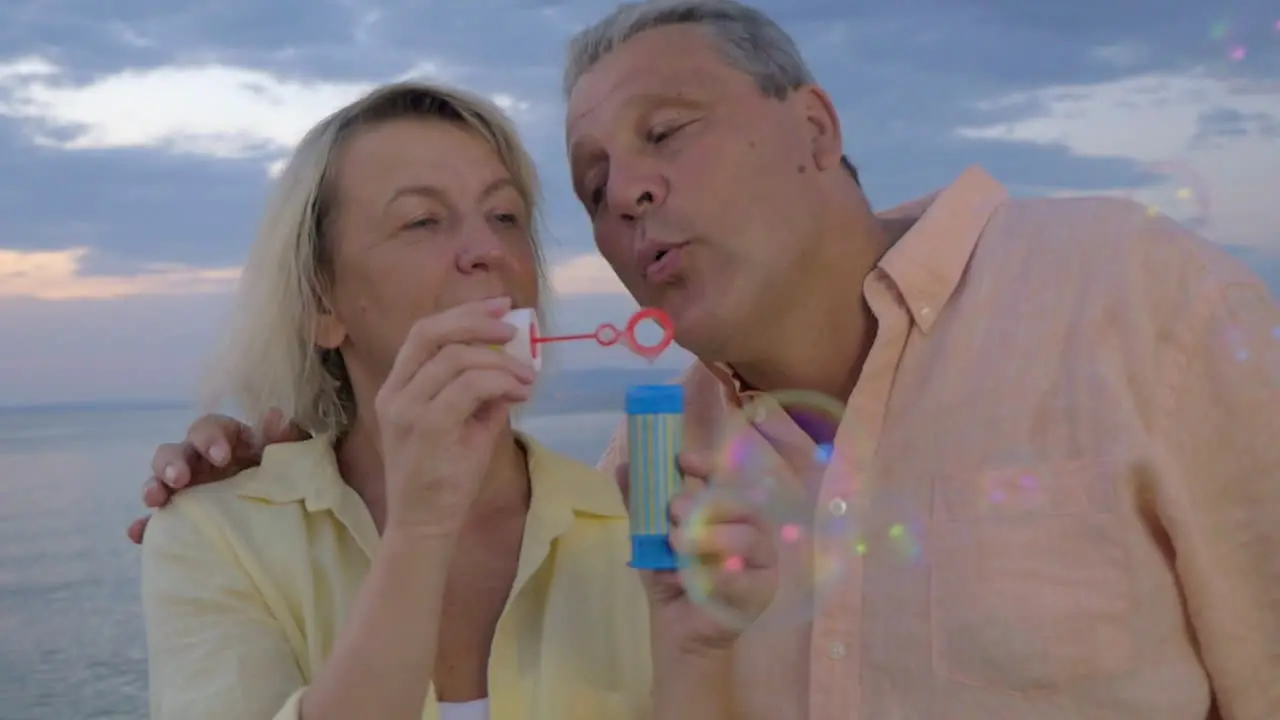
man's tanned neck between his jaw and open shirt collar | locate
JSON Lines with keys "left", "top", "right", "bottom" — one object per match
{"left": 732, "top": 204, "right": 908, "bottom": 404}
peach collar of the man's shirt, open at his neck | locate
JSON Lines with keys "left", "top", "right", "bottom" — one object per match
{"left": 705, "top": 165, "right": 1009, "bottom": 397}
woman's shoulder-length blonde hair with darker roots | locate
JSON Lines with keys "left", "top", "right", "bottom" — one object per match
{"left": 201, "top": 82, "right": 547, "bottom": 434}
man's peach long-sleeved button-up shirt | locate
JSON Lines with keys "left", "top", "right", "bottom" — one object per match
{"left": 602, "top": 168, "right": 1280, "bottom": 720}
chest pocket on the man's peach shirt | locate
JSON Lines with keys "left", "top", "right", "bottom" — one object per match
{"left": 929, "top": 461, "right": 1134, "bottom": 692}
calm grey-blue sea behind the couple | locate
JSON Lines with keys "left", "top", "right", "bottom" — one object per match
{"left": 0, "top": 406, "right": 621, "bottom": 720}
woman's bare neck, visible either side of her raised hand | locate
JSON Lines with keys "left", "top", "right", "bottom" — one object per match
{"left": 335, "top": 409, "right": 531, "bottom": 532}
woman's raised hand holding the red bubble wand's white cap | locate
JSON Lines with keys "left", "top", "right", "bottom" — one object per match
{"left": 375, "top": 299, "right": 535, "bottom": 536}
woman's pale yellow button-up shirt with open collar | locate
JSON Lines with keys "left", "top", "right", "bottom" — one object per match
{"left": 142, "top": 430, "right": 652, "bottom": 720}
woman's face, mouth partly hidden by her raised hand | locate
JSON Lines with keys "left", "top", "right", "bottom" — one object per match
{"left": 317, "top": 119, "right": 538, "bottom": 384}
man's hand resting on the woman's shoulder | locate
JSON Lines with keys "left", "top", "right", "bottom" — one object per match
{"left": 128, "top": 410, "right": 310, "bottom": 544}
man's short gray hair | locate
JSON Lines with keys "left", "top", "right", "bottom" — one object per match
{"left": 563, "top": 0, "right": 859, "bottom": 182}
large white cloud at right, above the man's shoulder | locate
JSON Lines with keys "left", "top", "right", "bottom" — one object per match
{"left": 957, "top": 73, "right": 1280, "bottom": 247}
